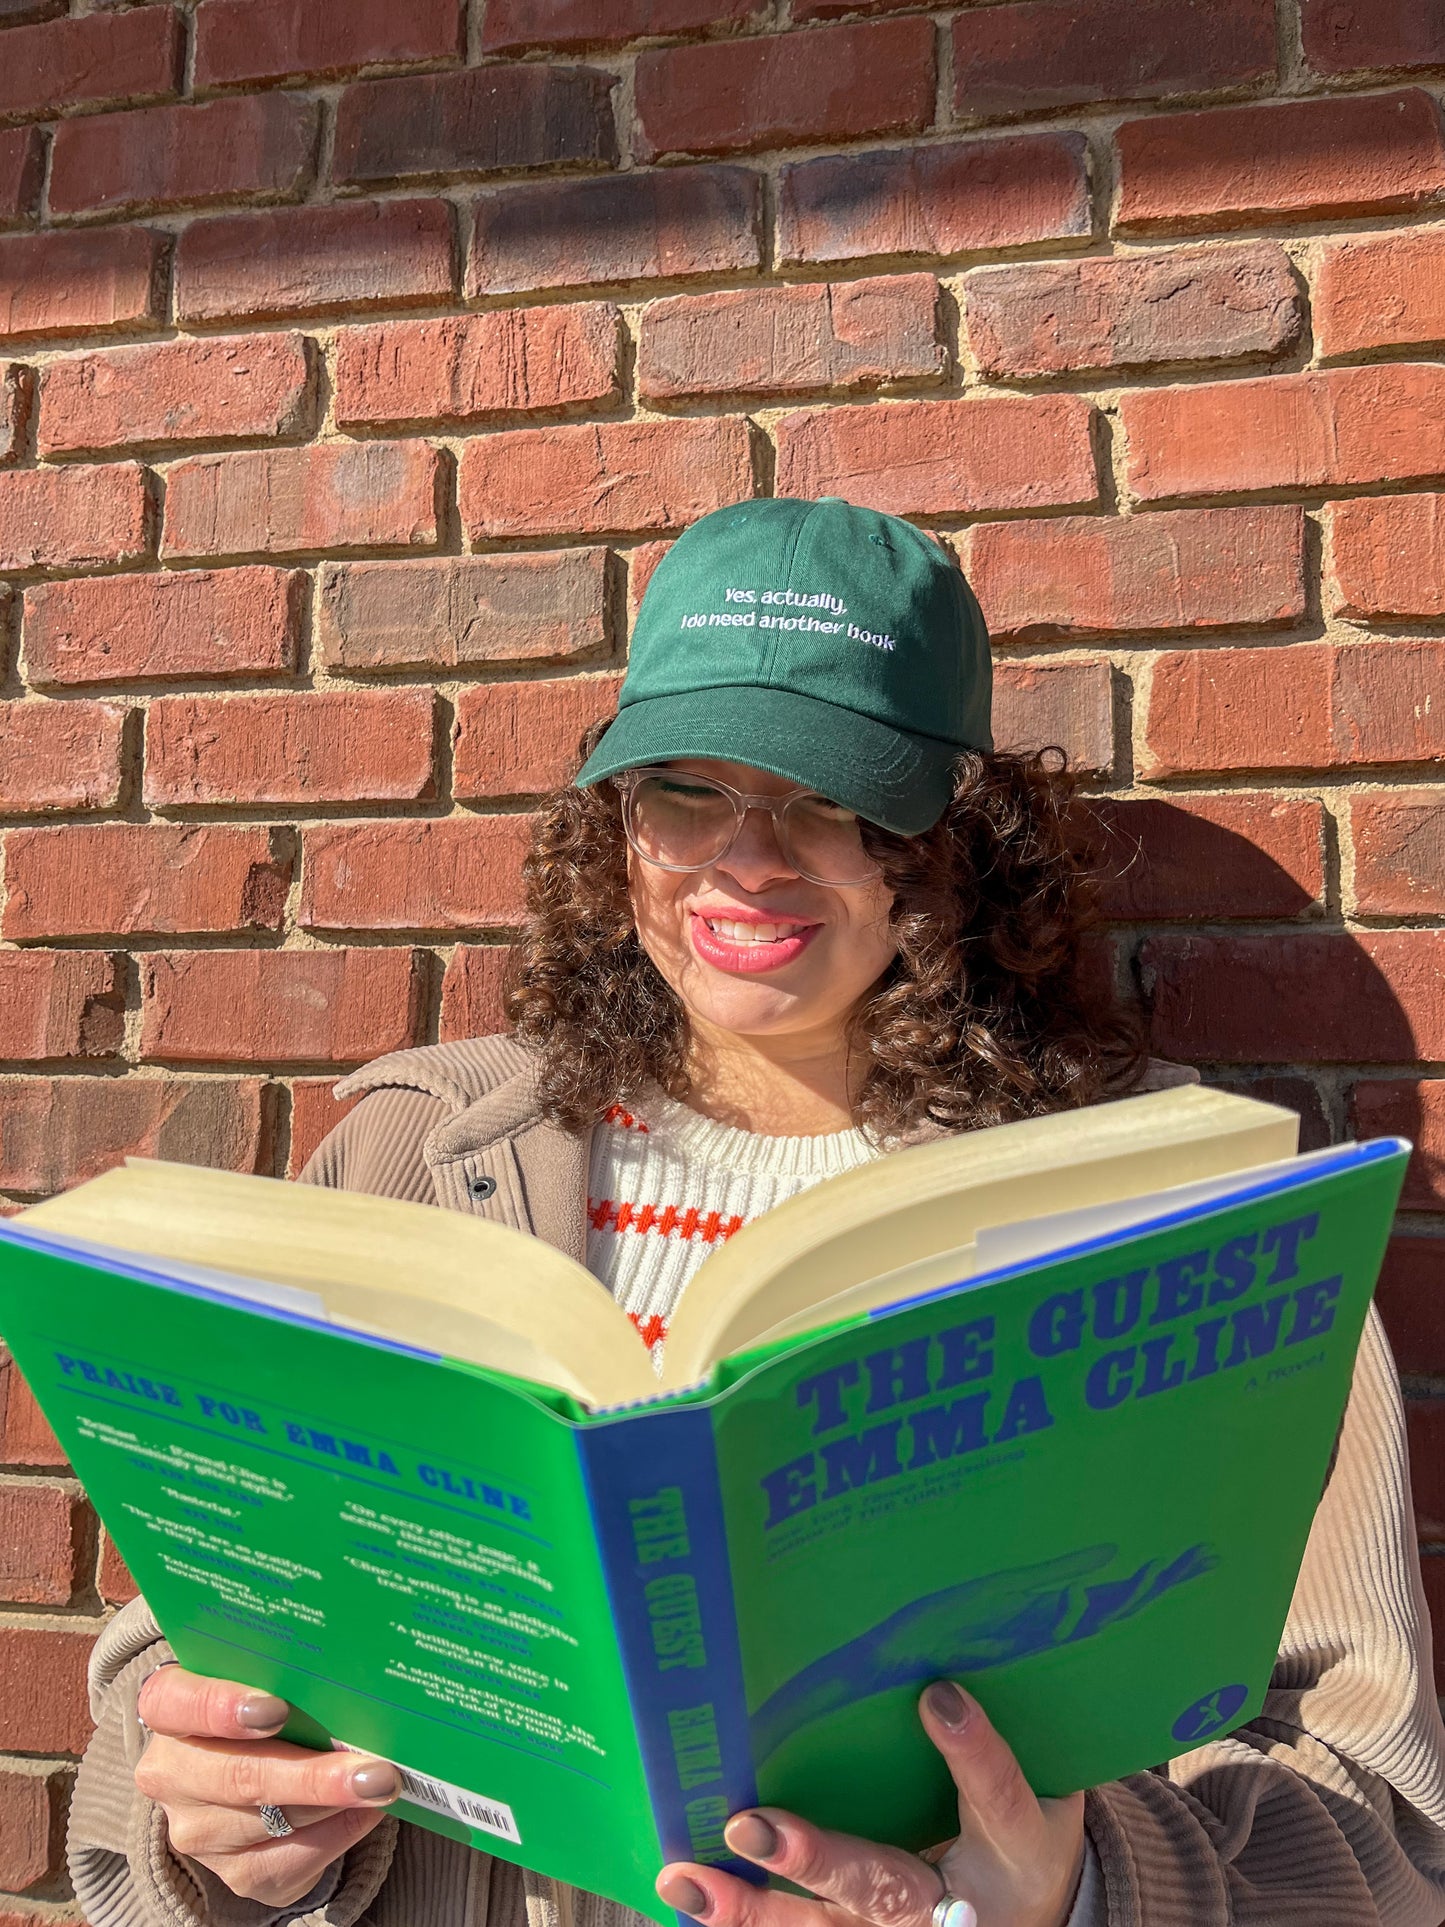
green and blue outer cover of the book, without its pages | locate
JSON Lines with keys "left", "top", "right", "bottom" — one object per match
{"left": 0, "top": 1141, "right": 1408, "bottom": 1921}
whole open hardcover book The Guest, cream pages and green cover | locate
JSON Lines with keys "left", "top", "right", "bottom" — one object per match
{"left": 0, "top": 1087, "right": 1408, "bottom": 1921}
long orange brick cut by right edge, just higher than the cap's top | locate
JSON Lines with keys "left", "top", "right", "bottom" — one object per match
{"left": 1119, "top": 362, "right": 1445, "bottom": 501}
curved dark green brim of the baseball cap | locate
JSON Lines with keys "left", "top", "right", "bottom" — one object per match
{"left": 576, "top": 684, "right": 959, "bottom": 836}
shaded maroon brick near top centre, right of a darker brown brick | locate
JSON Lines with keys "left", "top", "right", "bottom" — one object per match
{"left": 636, "top": 19, "right": 934, "bottom": 160}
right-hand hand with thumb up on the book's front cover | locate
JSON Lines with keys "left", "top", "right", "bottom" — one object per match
{"left": 657, "top": 1680, "right": 1085, "bottom": 1927}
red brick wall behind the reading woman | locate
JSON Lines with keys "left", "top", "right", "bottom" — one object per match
{"left": 0, "top": 0, "right": 1445, "bottom": 1903}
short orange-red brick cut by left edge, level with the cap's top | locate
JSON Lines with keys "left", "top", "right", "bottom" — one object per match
{"left": 0, "top": 462, "right": 148, "bottom": 568}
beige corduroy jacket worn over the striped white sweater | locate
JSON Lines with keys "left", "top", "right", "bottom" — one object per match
{"left": 69, "top": 1039, "right": 1445, "bottom": 1927}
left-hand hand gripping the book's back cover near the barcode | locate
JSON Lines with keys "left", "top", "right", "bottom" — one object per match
{"left": 135, "top": 1667, "right": 401, "bottom": 1908}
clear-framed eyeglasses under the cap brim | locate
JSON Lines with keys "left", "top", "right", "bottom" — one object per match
{"left": 617, "top": 769, "right": 879, "bottom": 888}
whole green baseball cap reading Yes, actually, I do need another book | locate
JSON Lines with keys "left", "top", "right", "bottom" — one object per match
{"left": 576, "top": 495, "right": 992, "bottom": 836}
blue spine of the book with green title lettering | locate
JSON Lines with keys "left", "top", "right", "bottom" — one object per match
{"left": 576, "top": 1405, "right": 765, "bottom": 1885}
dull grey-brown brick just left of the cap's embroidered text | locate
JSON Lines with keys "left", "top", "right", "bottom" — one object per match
{"left": 318, "top": 549, "right": 611, "bottom": 671}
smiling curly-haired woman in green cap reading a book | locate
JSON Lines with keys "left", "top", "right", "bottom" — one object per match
{"left": 71, "top": 501, "right": 1445, "bottom": 1927}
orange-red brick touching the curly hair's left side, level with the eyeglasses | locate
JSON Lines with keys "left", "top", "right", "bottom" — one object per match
{"left": 301, "top": 817, "right": 532, "bottom": 931}
